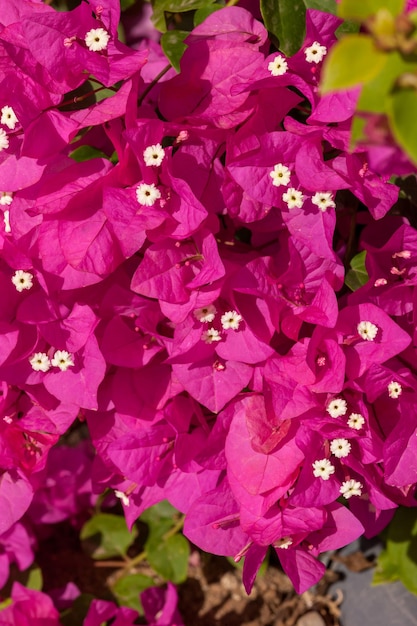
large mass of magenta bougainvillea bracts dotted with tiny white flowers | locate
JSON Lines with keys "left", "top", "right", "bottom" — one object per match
{"left": 0, "top": 0, "right": 417, "bottom": 596}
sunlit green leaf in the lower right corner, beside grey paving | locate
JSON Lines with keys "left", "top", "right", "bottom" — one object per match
{"left": 372, "top": 507, "right": 417, "bottom": 594}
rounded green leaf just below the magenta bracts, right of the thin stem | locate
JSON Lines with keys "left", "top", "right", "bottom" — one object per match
{"left": 145, "top": 532, "right": 190, "bottom": 584}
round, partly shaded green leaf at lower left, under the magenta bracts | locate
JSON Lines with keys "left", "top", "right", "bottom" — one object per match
{"left": 80, "top": 513, "right": 137, "bottom": 560}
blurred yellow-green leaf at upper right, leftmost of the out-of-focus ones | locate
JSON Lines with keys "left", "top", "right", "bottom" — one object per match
{"left": 321, "top": 34, "right": 388, "bottom": 93}
